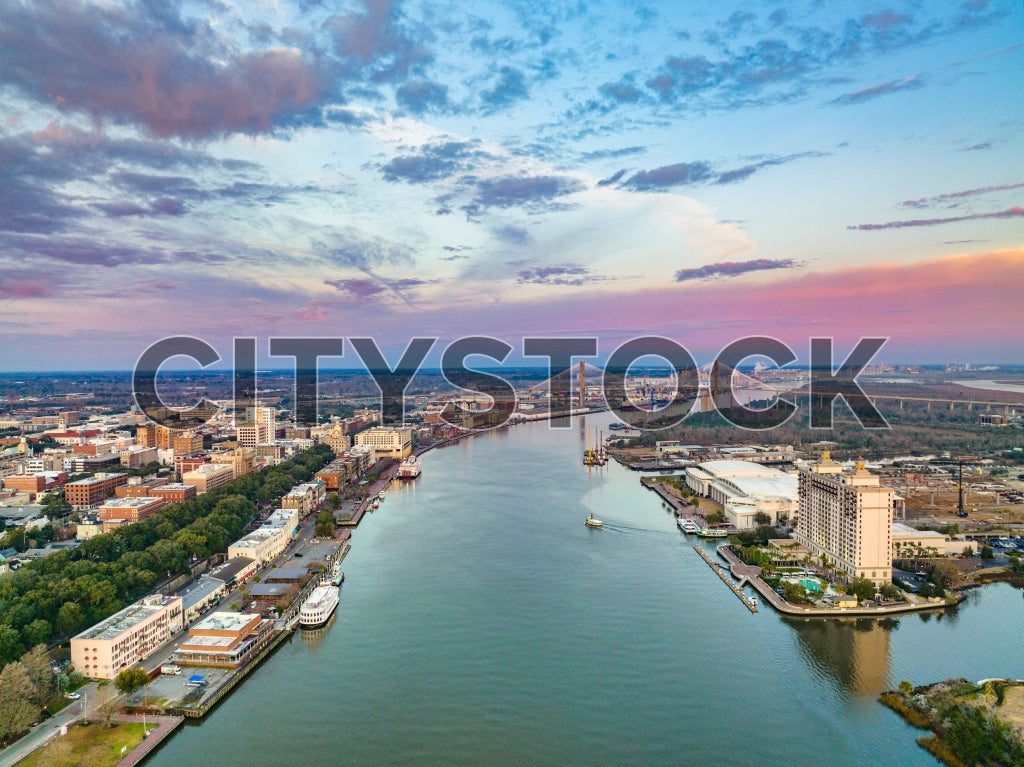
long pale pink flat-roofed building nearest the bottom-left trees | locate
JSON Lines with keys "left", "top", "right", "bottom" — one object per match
{"left": 71, "top": 594, "right": 182, "bottom": 679}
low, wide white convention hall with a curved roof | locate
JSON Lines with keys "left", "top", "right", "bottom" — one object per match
{"left": 686, "top": 460, "right": 799, "bottom": 529}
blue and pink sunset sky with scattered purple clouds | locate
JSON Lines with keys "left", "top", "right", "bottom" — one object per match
{"left": 0, "top": 0, "right": 1024, "bottom": 371}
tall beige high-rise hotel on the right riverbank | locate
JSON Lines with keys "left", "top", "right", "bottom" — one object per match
{"left": 796, "top": 453, "right": 894, "bottom": 586}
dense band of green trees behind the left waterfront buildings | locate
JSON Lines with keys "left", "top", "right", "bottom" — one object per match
{"left": 0, "top": 445, "right": 334, "bottom": 668}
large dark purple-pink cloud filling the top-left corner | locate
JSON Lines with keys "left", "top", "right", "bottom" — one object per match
{"left": 0, "top": 0, "right": 331, "bottom": 138}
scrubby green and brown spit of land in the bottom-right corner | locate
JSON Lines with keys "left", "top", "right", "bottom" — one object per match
{"left": 879, "top": 679, "right": 1024, "bottom": 767}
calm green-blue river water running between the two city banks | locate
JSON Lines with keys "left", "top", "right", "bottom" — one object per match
{"left": 150, "top": 418, "right": 1024, "bottom": 767}
